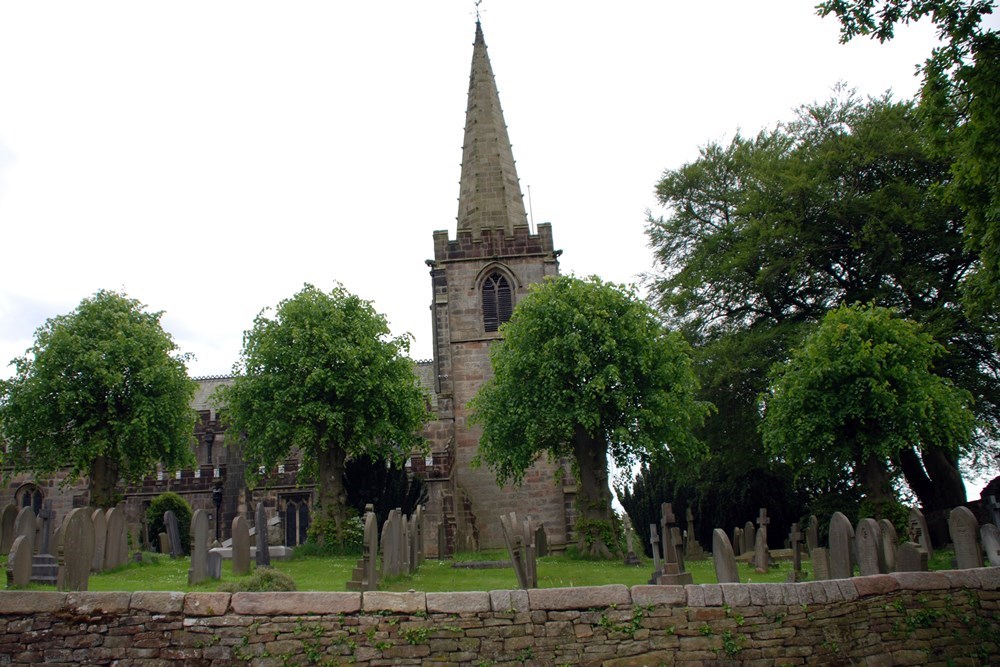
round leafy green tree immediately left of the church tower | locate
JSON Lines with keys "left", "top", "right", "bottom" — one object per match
{"left": 218, "top": 284, "right": 426, "bottom": 545}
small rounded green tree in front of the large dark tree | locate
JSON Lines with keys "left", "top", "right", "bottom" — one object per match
{"left": 760, "top": 305, "right": 974, "bottom": 510}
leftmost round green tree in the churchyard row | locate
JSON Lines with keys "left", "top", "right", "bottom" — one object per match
{"left": 0, "top": 290, "right": 197, "bottom": 507}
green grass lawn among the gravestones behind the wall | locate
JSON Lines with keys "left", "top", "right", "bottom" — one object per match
{"left": 7, "top": 549, "right": 953, "bottom": 592}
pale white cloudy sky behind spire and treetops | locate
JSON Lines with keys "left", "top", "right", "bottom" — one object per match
{"left": 0, "top": 0, "right": 968, "bottom": 377}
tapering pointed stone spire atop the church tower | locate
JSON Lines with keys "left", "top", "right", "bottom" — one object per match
{"left": 458, "top": 20, "right": 528, "bottom": 238}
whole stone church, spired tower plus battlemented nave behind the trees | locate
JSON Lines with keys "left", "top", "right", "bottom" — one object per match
{"left": 0, "top": 20, "right": 576, "bottom": 556}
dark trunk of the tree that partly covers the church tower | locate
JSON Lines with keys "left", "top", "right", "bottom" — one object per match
{"left": 573, "top": 425, "right": 619, "bottom": 559}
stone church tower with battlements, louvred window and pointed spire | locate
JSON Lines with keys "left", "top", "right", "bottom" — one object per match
{"left": 413, "top": 21, "right": 575, "bottom": 550}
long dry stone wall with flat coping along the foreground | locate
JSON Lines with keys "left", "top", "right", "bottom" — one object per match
{"left": 0, "top": 568, "right": 1000, "bottom": 667}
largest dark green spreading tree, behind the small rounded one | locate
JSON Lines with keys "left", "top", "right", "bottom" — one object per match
{"left": 647, "top": 89, "right": 1000, "bottom": 509}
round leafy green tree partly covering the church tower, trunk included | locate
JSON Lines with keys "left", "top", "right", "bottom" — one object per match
{"left": 471, "top": 277, "right": 709, "bottom": 557}
